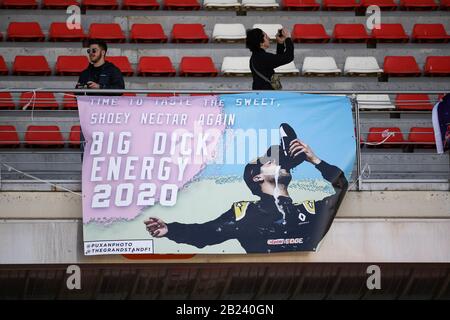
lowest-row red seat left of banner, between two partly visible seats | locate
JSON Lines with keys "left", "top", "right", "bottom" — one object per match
{"left": 25, "top": 126, "right": 64, "bottom": 147}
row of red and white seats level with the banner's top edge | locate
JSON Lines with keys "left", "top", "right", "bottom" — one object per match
{"left": 0, "top": 92, "right": 440, "bottom": 111}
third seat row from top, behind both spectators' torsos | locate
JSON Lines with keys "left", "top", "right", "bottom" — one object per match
{"left": 0, "top": 56, "right": 450, "bottom": 77}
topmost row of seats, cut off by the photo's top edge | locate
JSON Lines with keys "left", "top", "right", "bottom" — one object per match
{"left": 2, "top": 0, "right": 450, "bottom": 11}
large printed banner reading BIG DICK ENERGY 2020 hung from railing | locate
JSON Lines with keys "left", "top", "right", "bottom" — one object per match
{"left": 78, "top": 92, "right": 355, "bottom": 255}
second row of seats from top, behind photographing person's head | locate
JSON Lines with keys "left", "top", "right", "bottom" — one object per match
{"left": 0, "top": 22, "right": 450, "bottom": 43}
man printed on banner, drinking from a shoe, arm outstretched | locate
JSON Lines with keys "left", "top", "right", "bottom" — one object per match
{"left": 144, "top": 124, "right": 348, "bottom": 253}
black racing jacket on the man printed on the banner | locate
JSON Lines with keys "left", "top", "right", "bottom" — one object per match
{"left": 166, "top": 161, "right": 348, "bottom": 253}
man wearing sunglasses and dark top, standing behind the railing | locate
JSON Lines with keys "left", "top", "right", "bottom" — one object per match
{"left": 76, "top": 40, "right": 125, "bottom": 95}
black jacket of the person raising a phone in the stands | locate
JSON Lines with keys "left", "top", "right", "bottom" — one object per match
{"left": 250, "top": 38, "right": 294, "bottom": 90}
